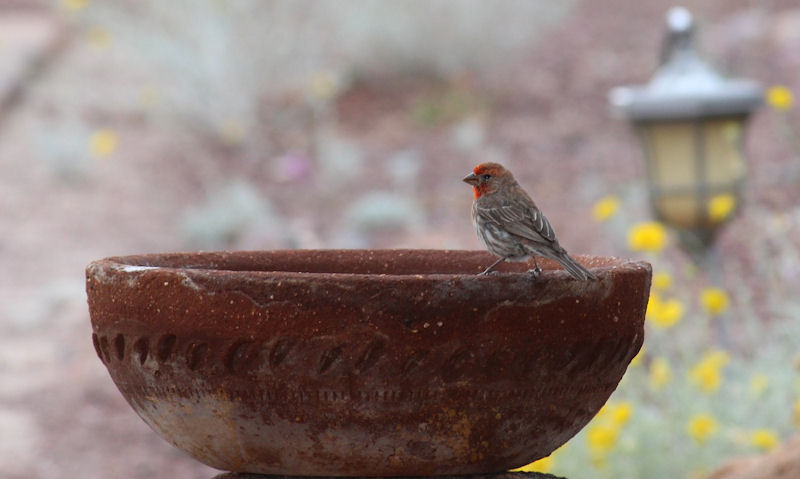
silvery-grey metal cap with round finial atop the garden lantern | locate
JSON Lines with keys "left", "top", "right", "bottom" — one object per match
{"left": 609, "top": 7, "right": 763, "bottom": 121}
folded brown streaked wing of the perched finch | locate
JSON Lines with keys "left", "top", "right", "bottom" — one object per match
{"left": 477, "top": 197, "right": 557, "bottom": 244}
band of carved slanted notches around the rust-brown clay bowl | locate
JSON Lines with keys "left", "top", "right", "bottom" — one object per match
{"left": 92, "top": 333, "right": 638, "bottom": 383}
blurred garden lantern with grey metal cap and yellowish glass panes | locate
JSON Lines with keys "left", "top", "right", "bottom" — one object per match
{"left": 609, "top": 7, "right": 763, "bottom": 253}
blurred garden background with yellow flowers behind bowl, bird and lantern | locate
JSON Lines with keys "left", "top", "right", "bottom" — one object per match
{"left": 0, "top": 0, "right": 800, "bottom": 479}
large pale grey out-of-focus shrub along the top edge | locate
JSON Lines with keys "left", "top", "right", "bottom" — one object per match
{"left": 59, "top": 0, "right": 574, "bottom": 139}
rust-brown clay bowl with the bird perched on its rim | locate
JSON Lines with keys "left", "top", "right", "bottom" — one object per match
{"left": 86, "top": 250, "right": 651, "bottom": 476}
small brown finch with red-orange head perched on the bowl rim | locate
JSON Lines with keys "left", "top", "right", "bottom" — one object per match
{"left": 463, "top": 163, "right": 596, "bottom": 280}
